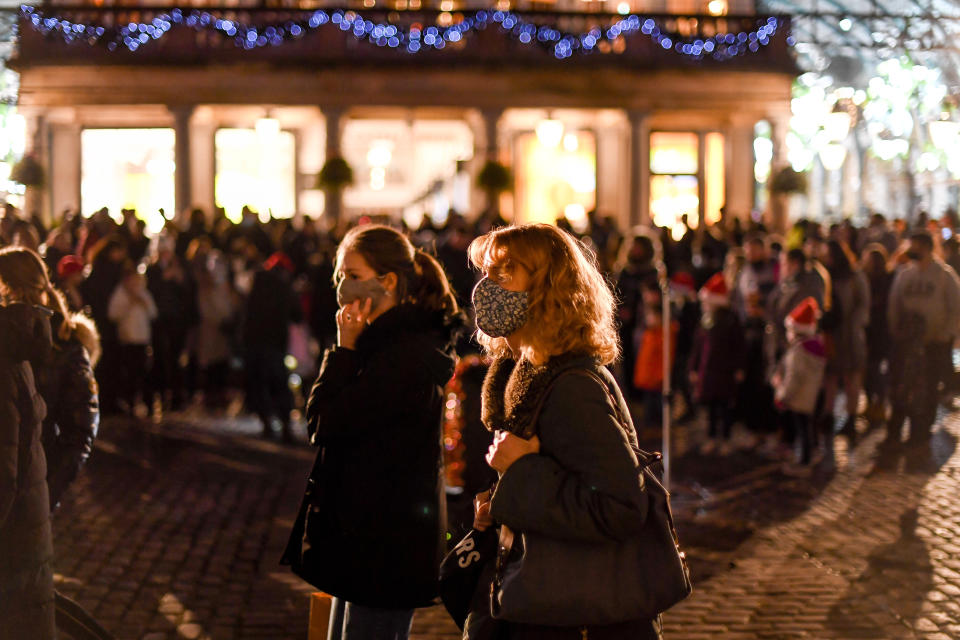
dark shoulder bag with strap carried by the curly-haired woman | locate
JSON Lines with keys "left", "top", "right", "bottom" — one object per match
{"left": 490, "top": 369, "right": 692, "bottom": 626}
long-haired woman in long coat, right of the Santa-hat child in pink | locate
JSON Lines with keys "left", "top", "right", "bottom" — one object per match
{"left": 821, "top": 240, "right": 870, "bottom": 435}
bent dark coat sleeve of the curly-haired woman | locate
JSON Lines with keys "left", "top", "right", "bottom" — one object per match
{"left": 491, "top": 376, "right": 648, "bottom": 542}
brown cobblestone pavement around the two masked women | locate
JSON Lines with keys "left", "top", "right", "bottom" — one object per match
{"left": 54, "top": 414, "right": 960, "bottom": 640}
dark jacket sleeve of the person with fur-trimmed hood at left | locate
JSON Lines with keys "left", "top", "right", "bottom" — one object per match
{"left": 47, "top": 345, "right": 100, "bottom": 508}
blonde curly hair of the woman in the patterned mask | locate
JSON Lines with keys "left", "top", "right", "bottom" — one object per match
{"left": 469, "top": 224, "right": 620, "bottom": 364}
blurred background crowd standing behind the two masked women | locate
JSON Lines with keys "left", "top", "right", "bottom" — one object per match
{"left": 0, "top": 202, "right": 960, "bottom": 464}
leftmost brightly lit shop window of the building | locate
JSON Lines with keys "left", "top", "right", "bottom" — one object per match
{"left": 80, "top": 129, "right": 176, "bottom": 233}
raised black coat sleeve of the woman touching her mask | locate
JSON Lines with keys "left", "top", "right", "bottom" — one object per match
{"left": 306, "top": 345, "right": 434, "bottom": 444}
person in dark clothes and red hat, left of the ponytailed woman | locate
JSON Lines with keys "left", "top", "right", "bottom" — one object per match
{"left": 243, "top": 253, "right": 301, "bottom": 442}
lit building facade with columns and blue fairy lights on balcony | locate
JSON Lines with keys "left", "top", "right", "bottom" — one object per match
{"left": 11, "top": 0, "right": 795, "bottom": 228}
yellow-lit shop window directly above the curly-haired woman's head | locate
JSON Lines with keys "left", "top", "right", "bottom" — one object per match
{"left": 515, "top": 128, "right": 597, "bottom": 229}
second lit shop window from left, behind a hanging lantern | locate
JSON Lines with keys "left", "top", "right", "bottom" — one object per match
{"left": 214, "top": 126, "right": 297, "bottom": 222}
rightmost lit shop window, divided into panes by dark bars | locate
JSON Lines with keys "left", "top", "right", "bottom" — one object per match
{"left": 650, "top": 132, "right": 726, "bottom": 238}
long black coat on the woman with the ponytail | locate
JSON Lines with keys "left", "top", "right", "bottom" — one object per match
{"left": 283, "top": 305, "right": 458, "bottom": 608}
